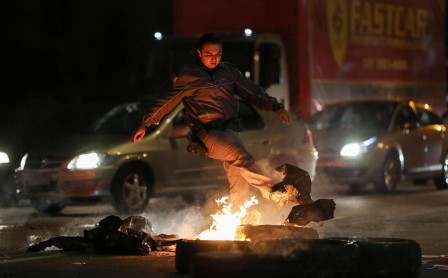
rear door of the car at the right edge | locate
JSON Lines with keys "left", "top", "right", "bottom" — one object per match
{"left": 416, "top": 104, "right": 446, "bottom": 171}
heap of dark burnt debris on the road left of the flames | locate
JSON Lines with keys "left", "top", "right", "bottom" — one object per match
{"left": 28, "top": 215, "right": 179, "bottom": 255}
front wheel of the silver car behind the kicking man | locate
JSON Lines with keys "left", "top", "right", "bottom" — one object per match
{"left": 111, "top": 167, "right": 151, "bottom": 213}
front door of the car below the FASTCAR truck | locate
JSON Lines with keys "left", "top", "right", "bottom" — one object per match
{"left": 391, "top": 104, "right": 426, "bottom": 173}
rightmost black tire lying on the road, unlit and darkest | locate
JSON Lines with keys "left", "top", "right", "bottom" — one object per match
{"left": 333, "top": 237, "right": 422, "bottom": 277}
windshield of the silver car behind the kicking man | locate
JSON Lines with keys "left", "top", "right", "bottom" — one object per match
{"left": 85, "top": 102, "right": 160, "bottom": 136}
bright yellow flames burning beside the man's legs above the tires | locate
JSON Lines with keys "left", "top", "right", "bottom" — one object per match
{"left": 195, "top": 196, "right": 258, "bottom": 240}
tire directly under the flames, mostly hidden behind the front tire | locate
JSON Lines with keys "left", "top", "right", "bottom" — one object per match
{"left": 175, "top": 240, "right": 249, "bottom": 274}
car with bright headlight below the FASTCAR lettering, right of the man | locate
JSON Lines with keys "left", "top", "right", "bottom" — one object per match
{"left": 307, "top": 100, "right": 448, "bottom": 192}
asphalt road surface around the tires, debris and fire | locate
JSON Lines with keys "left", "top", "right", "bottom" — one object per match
{"left": 0, "top": 180, "right": 448, "bottom": 278}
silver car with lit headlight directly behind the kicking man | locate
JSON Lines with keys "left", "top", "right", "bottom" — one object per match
{"left": 16, "top": 98, "right": 317, "bottom": 214}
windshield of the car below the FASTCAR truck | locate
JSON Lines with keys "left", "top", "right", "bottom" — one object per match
{"left": 308, "top": 102, "right": 396, "bottom": 130}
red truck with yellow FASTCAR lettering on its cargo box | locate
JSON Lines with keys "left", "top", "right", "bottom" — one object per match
{"left": 166, "top": 0, "right": 447, "bottom": 119}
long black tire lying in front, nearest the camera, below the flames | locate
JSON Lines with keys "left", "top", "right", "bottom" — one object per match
{"left": 190, "top": 239, "right": 359, "bottom": 278}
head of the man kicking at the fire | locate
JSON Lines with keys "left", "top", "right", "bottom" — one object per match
{"left": 197, "top": 33, "right": 222, "bottom": 69}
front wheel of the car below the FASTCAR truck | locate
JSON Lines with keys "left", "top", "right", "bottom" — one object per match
{"left": 374, "top": 153, "right": 401, "bottom": 192}
